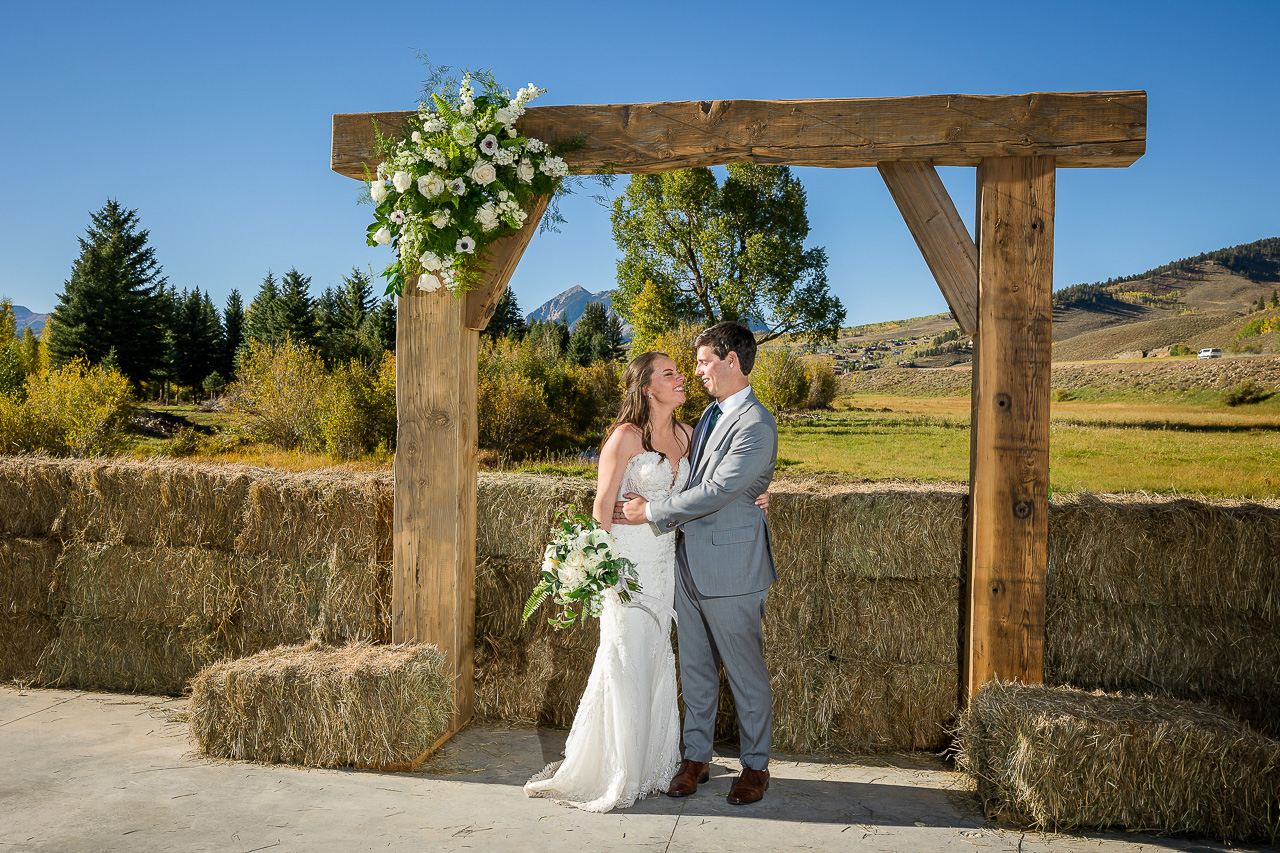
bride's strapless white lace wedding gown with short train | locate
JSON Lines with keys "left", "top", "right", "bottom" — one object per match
{"left": 525, "top": 451, "right": 689, "bottom": 812}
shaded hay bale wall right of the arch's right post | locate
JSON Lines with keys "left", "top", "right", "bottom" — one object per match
{"left": 1044, "top": 496, "right": 1280, "bottom": 735}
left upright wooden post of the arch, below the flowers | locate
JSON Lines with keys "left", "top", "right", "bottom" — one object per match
{"left": 392, "top": 288, "right": 480, "bottom": 731}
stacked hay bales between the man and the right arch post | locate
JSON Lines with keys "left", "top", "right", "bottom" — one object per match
{"left": 747, "top": 485, "right": 965, "bottom": 752}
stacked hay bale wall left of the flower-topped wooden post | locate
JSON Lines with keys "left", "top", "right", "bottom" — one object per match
{"left": 0, "top": 457, "right": 392, "bottom": 694}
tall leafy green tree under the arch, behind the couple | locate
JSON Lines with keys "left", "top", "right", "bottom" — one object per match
{"left": 613, "top": 164, "right": 845, "bottom": 342}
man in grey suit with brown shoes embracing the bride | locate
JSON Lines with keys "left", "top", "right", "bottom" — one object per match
{"left": 618, "top": 323, "right": 778, "bottom": 804}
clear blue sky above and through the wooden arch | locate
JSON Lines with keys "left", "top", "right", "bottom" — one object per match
{"left": 0, "top": 0, "right": 1280, "bottom": 324}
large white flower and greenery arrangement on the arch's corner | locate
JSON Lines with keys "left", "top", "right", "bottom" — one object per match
{"left": 369, "top": 72, "right": 568, "bottom": 295}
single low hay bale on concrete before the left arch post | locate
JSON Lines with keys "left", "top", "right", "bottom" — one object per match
{"left": 188, "top": 643, "right": 453, "bottom": 767}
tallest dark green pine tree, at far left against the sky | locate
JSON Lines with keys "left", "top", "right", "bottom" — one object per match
{"left": 49, "top": 199, "right": 166, "bottom": 383}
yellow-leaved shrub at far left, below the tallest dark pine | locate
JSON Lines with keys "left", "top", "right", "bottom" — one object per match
{"left": 0, "top": 360, "right": 133, "bottom": 456}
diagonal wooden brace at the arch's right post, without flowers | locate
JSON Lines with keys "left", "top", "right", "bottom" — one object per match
{"left": 879, "top": 160, "right": 978, "bottom": 334}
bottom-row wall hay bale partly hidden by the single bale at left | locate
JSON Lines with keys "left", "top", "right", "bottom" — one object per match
{"left": 36, "top": 616, "right": 248, "bottom": 695}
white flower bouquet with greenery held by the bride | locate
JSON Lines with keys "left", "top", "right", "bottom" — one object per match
{"left": 522, "top": 506, "right": 640, "bottom": 628}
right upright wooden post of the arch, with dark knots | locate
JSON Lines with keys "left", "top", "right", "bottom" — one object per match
{"left": 966, "top": 158, "right": 1055, "bottom": 695}
